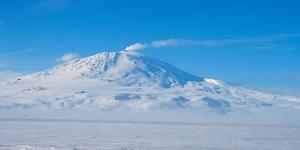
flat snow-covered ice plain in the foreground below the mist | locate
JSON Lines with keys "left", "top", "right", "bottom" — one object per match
{"left": 0, "top": 119, "right": 300, "bottom": 150}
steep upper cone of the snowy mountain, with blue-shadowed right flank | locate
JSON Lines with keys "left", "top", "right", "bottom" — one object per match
{"left": 38, "top": 51, "right": 203, "bottom": 88}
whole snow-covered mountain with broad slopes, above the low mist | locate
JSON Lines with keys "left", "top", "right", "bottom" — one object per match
{"left": 0, "top": 51, "right": 300, "bottom": 112}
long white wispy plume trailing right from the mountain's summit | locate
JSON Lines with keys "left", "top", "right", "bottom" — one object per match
{"left": 126, "top": 34, "right": 300, "bottom": 50}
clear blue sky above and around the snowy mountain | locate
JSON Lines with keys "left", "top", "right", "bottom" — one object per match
{"left": 0, "top": 0, "right": 300, "bottom": 93}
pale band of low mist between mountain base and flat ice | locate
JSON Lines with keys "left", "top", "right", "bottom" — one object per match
{"left": 0, "top": 109, "right": 300, "bottom": 126}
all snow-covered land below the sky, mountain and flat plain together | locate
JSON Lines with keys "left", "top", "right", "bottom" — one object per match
{"left": 0, "top": 50, "right": 300, "bottom": 150}
